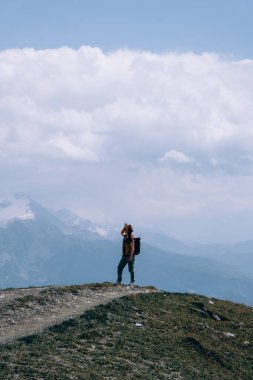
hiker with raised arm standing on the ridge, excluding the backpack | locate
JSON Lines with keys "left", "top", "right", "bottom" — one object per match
{"left": 117, "top": 223, "right": 135, "bottom": 286}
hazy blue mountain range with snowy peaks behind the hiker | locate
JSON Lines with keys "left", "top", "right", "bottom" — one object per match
{"left": 0, "top": 194, "right": 253, "bottom": 305}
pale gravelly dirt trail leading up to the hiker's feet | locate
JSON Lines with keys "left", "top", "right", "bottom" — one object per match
{"left": 0, "top": 284, "right": 154, "bottom": 344}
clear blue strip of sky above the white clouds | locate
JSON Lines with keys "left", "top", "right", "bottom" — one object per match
{"left": 0, "top": 0, "right": 253, "bottom": 58}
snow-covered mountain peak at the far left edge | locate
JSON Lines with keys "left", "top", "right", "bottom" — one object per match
{"left": 0, "top": 194, "right": 35, "bottom": 227}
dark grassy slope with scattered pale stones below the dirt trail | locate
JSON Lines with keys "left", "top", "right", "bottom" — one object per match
{"left": 0, "top": 292, "right": 253, "bottom": 380}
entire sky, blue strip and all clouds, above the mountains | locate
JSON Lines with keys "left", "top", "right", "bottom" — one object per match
{"left": 0, "top": 0, "right": 253, "bottom": 242}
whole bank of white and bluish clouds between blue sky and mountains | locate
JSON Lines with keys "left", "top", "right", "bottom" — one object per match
{"left": 0, "top": 46, "right": 253, "bottom": 238}
